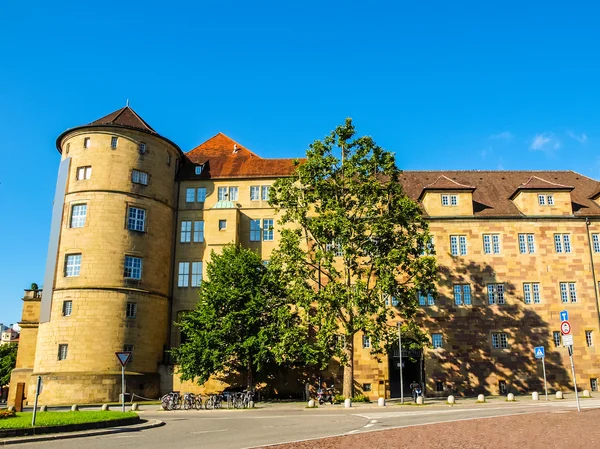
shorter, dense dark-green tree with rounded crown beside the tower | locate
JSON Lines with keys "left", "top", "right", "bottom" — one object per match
{"left": 172, "top": 245, "right": 306, "bottom": 388}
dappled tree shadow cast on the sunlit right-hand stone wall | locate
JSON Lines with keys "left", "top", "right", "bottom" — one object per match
{"left": 420, "top": 260, "right": 572, "bottom": 395}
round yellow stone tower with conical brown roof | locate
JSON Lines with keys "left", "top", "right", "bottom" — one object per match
{"left": 28, "top": 107, "right": 182, "bottom": 404}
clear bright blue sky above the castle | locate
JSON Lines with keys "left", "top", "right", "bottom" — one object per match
{"left": 0, "top": 0, "right": 600, "bottom": 324}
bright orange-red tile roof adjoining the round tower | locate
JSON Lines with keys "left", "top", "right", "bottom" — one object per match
{"left": 180, "top": 133, "right": 298, "bottom": 179}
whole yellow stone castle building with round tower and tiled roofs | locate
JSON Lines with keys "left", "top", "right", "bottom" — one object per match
{"left": 9, "top": 107, "right": 600, "bottom": 404}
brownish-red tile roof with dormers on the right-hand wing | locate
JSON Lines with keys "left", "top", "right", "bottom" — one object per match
{"left": 400, "top": 170, "right": 600, "bottom": 217}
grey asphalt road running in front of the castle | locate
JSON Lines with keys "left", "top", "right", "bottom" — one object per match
{"left": 14, "top": 399, "right": 600, "bottom": 449}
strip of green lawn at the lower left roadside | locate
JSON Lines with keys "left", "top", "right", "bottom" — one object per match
{"left": 0, "top": 411, "right": 137, "bottom": 429}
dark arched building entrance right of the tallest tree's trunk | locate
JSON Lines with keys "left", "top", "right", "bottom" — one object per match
{"left": 388, "top": 342, "right": 425, "bottom": 401}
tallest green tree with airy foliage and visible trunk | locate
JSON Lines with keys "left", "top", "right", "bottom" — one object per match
{"left": 270, "top": 119, "right": 436, "bottom": 397}
